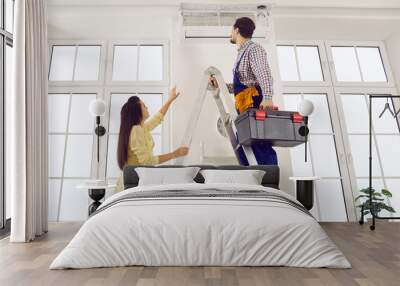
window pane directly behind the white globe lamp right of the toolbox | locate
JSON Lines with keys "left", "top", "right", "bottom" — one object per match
{"left": 304, "top": 94, "right": 332, "bottom": 134}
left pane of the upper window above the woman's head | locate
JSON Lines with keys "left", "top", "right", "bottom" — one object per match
{"left": 112, "top": 46, "right": 138, "bottom": 81}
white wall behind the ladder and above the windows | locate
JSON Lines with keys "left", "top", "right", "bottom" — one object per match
{"left": 49, "top": 6, "right": 400, "bottom": 198}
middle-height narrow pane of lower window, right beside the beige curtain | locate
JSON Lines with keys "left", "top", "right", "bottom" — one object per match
{"left": 48, "top": 135, "right": 65, "bottom": 177}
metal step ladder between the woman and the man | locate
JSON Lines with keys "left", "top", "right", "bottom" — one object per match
{"left": 176, "top": 66, "right": 258, "bottom": 165}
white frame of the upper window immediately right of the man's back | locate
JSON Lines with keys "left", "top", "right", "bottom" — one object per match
{"left": 276, "top": 40, "right": 331, "bottom": 87}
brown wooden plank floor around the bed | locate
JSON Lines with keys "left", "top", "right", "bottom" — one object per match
{"left": 0, "top": 222, "right": 400, "bottom": 286}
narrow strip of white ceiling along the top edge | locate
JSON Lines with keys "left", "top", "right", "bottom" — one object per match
{"left": 47, "top": 0, "right": 400, "bottom": 9}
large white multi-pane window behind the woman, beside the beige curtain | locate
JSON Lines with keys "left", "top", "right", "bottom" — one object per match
{"left": 48, "top": 41, "right": 169, "bottom": 221}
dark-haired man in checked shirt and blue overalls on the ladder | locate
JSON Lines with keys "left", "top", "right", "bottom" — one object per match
{"left": 209, "top": 17, "right": 278, "bottom": 166}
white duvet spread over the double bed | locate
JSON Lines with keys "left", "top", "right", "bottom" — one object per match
{"left": 50, "top": 183, "right": 351, "bottom": 269}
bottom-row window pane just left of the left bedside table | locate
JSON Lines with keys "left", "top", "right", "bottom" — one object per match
{"left": 60, "top": 180, "right": 89, "bottom": 221}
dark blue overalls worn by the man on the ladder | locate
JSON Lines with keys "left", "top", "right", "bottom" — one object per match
{"left": 233, "top": 48, "right": 278, "bottom": 166}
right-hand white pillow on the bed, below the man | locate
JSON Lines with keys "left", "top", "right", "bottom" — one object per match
{"left": 200, "top": 170, "right": 265, "bottom": 185}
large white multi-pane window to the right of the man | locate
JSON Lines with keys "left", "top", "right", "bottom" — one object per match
{"left": 277, "top": 42, "right": 400, "bottom": 221}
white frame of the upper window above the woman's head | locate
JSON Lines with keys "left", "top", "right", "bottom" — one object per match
{"left": 106, "top": 39, "right": 170, "bottom": 87}
